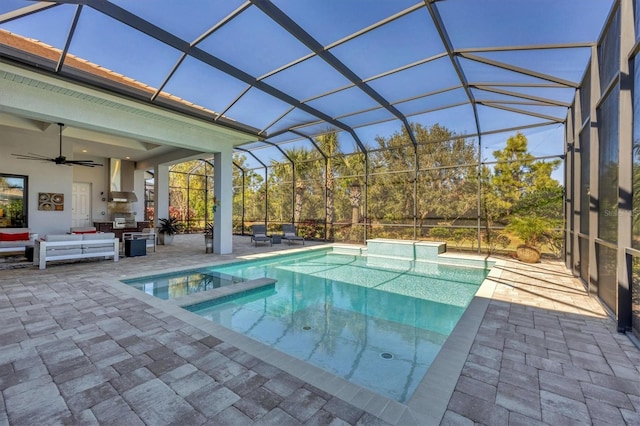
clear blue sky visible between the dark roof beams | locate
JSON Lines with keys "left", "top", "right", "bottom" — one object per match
{"left": 0, "top": 0, "right": 613, "bottom": 177}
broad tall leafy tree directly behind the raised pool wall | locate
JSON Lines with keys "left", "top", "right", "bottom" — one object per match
{"left": 369, "top": 123, "right": 477, "bottom": 240}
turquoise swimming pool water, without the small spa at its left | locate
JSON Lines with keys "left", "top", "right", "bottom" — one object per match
{"left": 126, "top": 250, "right": 496, "bottom": 402}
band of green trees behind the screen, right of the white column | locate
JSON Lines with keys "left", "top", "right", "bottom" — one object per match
{"left": 228, "top": 128, "right": 563, "bottom": 250}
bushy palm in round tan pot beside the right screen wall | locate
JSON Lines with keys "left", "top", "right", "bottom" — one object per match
{"left": 505, "top": 216, "right": 553, "bottom": 263}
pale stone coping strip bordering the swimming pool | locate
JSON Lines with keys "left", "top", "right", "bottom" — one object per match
{"left": 100, "top": 244, "right": 504, "bottom": 425}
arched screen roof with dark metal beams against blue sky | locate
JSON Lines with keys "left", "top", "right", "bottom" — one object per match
{"left": 0, "top": 0, "right": 616, "bottom": 166}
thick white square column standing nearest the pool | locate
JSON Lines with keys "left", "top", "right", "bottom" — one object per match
{"left": 213, "top": 149, "right": 233, "bottom": 254}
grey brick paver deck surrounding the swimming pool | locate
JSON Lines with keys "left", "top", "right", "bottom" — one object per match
{"left": 0, "top": 235, "right": 640, "bottom": 426}
